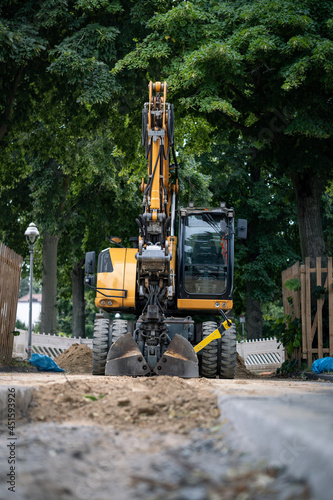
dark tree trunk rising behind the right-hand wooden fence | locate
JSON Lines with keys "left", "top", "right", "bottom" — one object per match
{"left": 292, "top": 174, "right": 326, "bottom": 266}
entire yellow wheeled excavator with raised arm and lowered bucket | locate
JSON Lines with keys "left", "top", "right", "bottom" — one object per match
{"left": 85, "top": 82, "right": 247, "bottom": 378}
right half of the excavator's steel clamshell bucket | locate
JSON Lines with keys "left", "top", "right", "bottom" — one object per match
{"left": 154, "top": 334, "right": 199, "bottom": 378}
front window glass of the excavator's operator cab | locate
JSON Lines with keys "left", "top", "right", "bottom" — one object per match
{"left": 180, "top": 212, "right": 230, "bottom": 296}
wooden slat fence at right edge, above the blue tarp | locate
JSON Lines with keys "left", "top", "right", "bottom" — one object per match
{"left": 282, "top": 257, "right": 333, "bottom": 367}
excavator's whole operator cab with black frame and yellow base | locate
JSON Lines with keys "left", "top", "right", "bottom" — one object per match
{"left": 178, "top": 207, "right": 234, "bottom": 310}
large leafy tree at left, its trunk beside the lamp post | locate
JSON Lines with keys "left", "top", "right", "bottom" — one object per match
{"left": 0, "top": 0, "right": 161, "bottom": 331}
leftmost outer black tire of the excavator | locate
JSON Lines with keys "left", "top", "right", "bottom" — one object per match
{"left": 92, "top": 318, "right": 111, "bottom": 375}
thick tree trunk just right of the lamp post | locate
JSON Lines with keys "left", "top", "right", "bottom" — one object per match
{"left": 40, "top": 231, "right": 59, "bottom": 333}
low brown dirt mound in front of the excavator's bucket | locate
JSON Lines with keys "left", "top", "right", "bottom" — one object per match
{"left": 29, "top": 377, "right": 219, "bottom": 433}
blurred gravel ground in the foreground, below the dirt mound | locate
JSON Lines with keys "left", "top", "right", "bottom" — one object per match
{"left": 0, "top": 422, "right": 311, "bottom": 500}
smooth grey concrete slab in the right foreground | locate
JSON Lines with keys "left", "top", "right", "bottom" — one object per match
{"left": 218, "top": 393, "right": 333, "bottom": 500}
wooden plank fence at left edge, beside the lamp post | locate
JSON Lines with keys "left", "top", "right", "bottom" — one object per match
{"left": 0, "top": 243, "right": 23, "bottom": 364}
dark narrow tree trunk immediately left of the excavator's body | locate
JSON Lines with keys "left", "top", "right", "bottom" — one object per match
{"left": 72, "top": 260, "right": 85, "bottom": 337}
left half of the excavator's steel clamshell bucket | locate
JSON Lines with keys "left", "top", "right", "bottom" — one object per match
{"left": 105, "top": 333, "right": 151, "bottom": 377}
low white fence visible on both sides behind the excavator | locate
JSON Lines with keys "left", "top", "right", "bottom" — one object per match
{"left": 13, "top": 330, "right": 285, "bottom": 371}
